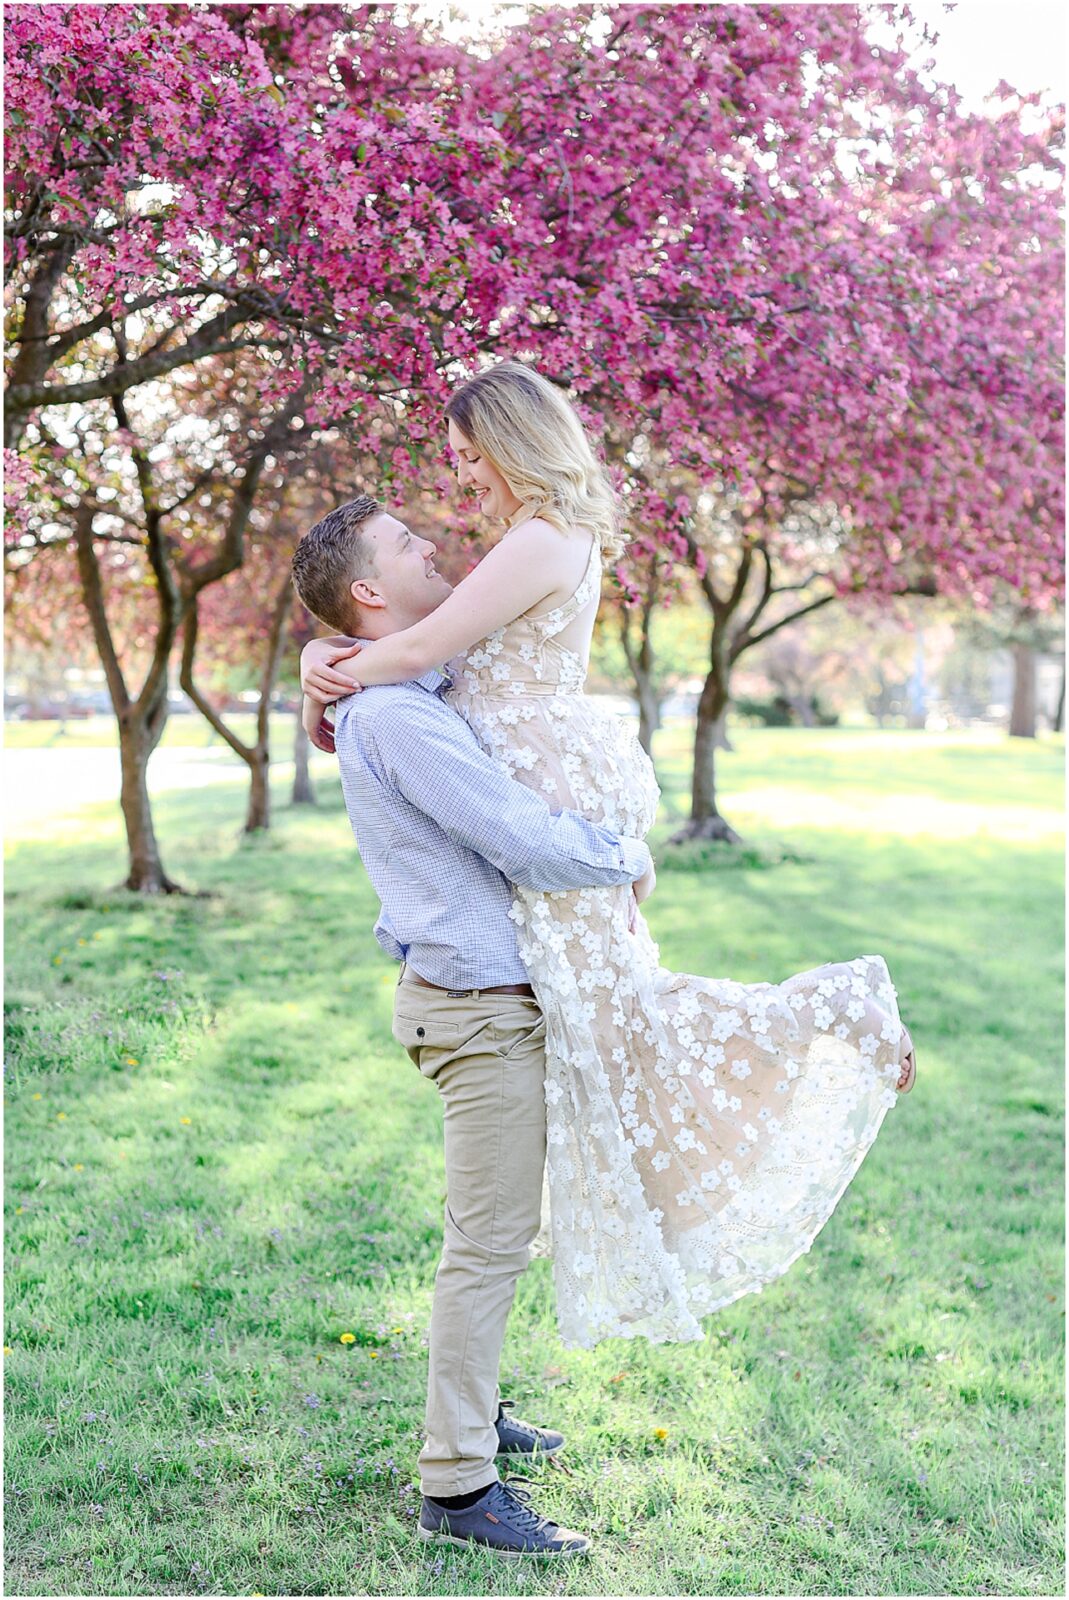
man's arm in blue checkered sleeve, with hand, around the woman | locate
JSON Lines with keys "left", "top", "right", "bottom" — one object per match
{"left": 371, "top": 693, "right": 650, "bottom": 891}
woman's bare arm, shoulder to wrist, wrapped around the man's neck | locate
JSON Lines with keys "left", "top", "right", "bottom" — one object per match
{"left": 329, "top": 518, "right": 568, "bottom": 686}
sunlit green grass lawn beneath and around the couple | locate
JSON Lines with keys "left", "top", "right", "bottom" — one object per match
{"left": 5, "top": 730, "right": 1064, "bottom": 1595}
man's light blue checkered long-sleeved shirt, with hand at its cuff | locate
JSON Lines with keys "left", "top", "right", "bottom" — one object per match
{"left": 334, "top": 670, "right": 650, "bottom": 989}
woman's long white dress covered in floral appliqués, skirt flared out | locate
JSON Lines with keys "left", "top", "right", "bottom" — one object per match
{"left": 446, "top": 542, "right": 904, "bottom": 1347}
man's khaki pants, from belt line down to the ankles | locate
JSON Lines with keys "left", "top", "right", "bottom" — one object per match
{"left": 394, "top": 966, "right": 546, "bottom": 1496}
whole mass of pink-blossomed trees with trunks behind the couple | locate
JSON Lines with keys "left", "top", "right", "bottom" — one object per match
{"left": 5, "top": 5, "right": 1064, "bottom": 893}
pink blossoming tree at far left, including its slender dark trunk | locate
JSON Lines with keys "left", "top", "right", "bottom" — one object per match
{"left": 5, "top": 5, "right": 499, "bottom": 893}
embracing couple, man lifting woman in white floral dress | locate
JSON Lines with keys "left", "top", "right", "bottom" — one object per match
{"left": 293, "top": 362, "right": 915, "bottom": 1557}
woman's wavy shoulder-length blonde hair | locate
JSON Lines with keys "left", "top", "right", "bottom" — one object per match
{"left": 445, "top": 362, "right": 627, "bottom": 562}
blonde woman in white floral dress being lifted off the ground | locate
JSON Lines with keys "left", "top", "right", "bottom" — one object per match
{"left": 306, "top": 362, "right": 914, "bottom": 1347}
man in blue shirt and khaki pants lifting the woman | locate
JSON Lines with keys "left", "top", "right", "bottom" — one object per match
{"left": 293, "top": 496, "right": 653, "bottom": 1557}
